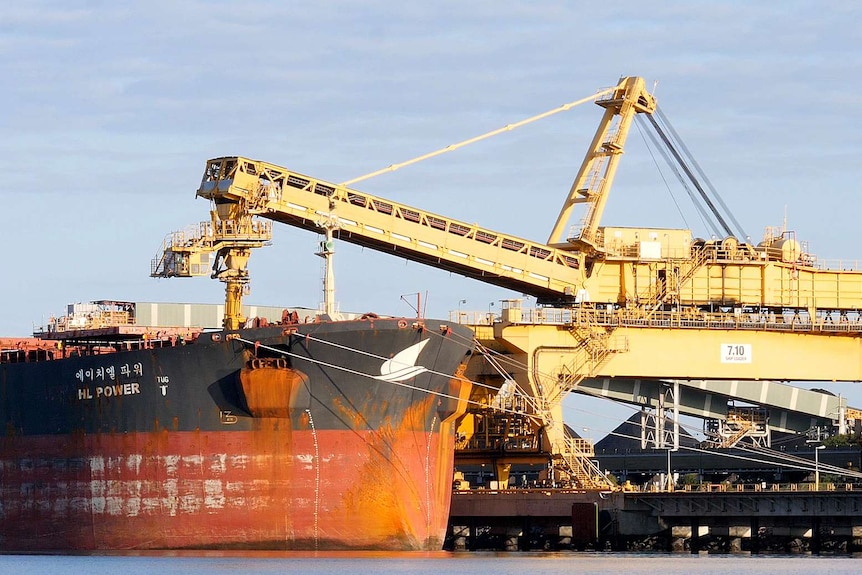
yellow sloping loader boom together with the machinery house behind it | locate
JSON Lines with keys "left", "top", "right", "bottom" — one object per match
{"left": 198, "top": 137, "right": 862, "bottom": 324}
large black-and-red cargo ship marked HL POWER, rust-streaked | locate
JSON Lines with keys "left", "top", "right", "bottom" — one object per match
{"left": 0, "top": 306, "right": 473, "bottom": 552}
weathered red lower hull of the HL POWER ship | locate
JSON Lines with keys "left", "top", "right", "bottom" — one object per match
{"left": 0, "top": 420, "right": 460, "bottom": 551}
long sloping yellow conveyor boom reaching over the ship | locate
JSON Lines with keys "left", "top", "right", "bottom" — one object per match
{"left": 198, "top": 157, "right": 581, "bottom": 298}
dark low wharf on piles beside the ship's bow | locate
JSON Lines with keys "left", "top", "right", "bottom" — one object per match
{"left": 447, "top": 483, "right": 862, "bottom": 554}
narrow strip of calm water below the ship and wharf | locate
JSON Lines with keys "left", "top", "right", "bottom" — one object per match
{"left": 0, "top": 552, "right": 862, "bottom": 575}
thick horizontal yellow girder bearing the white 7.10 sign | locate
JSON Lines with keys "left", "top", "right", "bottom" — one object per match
{"left": 497, "top": 314, "right": 862, "bottom": 387}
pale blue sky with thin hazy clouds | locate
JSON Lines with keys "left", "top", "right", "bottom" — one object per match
{"left": 0, "top": 0, "right": 862, "bottom": 440}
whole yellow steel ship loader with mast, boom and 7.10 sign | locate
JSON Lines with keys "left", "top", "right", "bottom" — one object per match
{"left": 154, "top": 77, "right": 862, "bottom": 484}
